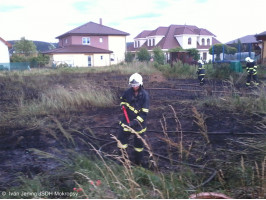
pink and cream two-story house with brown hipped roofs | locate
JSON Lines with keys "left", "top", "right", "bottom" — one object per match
{"left": 43, "top": 20, "right": 129, "bottom": 67}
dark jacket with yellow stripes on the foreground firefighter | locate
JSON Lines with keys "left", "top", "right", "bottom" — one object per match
{"left": 120, "top": 87, "right": 150, "bottom": 133}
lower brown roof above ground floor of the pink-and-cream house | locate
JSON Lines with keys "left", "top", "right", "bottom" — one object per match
{"left": 43, "top": 45, "right": 113, "bottom": 54}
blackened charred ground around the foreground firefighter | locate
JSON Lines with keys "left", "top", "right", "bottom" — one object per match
{"left": 0, "top": 73, "right": 266, "bottom": 197}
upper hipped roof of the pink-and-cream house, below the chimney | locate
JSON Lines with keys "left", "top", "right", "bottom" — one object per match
{"left": 56, "top": 22, "right": 129, "bottom": 39}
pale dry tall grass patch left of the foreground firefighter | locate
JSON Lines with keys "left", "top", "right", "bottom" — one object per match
{"left": 0, "top": 78, "right": 117, "bottom": 130}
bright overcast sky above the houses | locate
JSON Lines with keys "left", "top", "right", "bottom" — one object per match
{"left": 0, "top": 0, "right": 266, "bottom": 43}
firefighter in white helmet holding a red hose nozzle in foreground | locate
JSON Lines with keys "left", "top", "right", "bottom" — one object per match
{"left": 118, "top": 73, "right": 150, "bottom": 165}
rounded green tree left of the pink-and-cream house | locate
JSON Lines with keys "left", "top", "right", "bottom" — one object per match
{"left": 13, "top": 37, "right": 37, "bottom": 57}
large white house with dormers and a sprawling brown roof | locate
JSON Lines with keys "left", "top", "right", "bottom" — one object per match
{"left": 127, "top": 25, "right": 220, "bottom": 61}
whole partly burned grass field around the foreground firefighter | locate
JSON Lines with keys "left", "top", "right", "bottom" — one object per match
{"left": 0, "top": 69, "right": 266, "bottom": 198}
